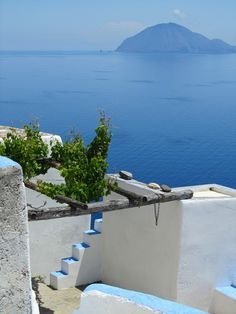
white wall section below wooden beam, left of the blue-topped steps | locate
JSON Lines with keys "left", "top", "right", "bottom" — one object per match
{"left": 29, "top": 215, "right": 90, "bottom": 284}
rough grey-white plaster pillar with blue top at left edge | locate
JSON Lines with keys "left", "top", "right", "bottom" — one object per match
{"left": 0, "top": 157, "right": 32, "bottom": 314}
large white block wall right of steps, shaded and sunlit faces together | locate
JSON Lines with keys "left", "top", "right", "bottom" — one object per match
{"left": 102, "top": 180, "right": 236, "bottom": 313}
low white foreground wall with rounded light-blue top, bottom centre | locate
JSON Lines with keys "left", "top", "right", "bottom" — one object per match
{"left": 73, "top": 284, "right": 206, "bottom": 314}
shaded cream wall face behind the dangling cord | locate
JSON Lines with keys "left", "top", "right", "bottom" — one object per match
{"left": 102, "top": 201, "right": 181, "bottom": 300}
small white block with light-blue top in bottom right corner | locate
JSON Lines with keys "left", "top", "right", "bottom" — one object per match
{"left": 211, "top": 285, "right": 236, "bottom": 314}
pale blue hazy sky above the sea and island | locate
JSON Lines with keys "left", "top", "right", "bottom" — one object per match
{"left": 0, "top": 0, "right": 236, "bottom": 50}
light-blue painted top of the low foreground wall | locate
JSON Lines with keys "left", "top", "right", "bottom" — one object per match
{"left": 84, "top": 284, "right": 207, "bottom": 314}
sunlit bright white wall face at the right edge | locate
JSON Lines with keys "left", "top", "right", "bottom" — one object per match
{"left": 177, "top": 198, "right": 236, "bottom": 309}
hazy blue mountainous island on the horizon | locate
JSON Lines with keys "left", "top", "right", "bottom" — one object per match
{"left": 116, "top": 23, "right": 236, "bottom": 54}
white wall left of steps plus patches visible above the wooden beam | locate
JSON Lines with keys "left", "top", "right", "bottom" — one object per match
{"left": 26, "top": 168, "right": 91, "bottom": 284}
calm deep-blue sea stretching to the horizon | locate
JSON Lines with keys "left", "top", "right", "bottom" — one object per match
{"left": 0, "top": 52, "right": 236, "bottom": 187}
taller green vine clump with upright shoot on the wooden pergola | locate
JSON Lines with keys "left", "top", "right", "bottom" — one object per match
{"left": 39, "top": 114, "right": 112, "bottom": 203}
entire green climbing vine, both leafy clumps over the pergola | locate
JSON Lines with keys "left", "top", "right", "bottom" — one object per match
{"left": 0, "top": 113, "right": 112, "bottom": 203}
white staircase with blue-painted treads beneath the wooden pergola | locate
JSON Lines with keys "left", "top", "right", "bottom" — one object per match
{"left": 50, "top": 219, "right": 102, "bottom": 290}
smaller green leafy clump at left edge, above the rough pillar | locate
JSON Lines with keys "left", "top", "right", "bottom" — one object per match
{"left": 0, "top": 124, "right": 48, "bottom": 179}
